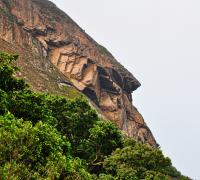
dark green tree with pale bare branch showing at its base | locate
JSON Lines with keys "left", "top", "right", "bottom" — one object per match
{"left": 78, "top": 121, "right": 123, "bottom": 173}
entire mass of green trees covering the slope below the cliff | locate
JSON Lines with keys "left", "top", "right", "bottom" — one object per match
{"left": 0, "top": 53, "right": 188, "bottom": 180}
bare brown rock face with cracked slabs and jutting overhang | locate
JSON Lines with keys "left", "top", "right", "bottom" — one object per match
{"left": 0, "top": 0, "right": 157, "bottom": 147}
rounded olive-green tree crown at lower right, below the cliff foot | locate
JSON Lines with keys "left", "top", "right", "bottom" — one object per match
{"left": 104, "top": 139, "right": 183, "bottom": 180}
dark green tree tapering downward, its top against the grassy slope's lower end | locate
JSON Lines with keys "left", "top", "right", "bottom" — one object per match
{"left": 44, "top": 96, "right": 99, "bottom": 148}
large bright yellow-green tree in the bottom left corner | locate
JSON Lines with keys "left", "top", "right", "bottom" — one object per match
{"left": 0, "top": 114, "right": 70, "bottom": 179}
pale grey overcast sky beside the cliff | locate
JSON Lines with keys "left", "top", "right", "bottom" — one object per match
{"left": 52, "top": 0, "right": 200, "bottom": 180}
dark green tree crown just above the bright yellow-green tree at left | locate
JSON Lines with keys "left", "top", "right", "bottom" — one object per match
{"left": 8, "top": 90, "right": 57, "bottom": 125}
